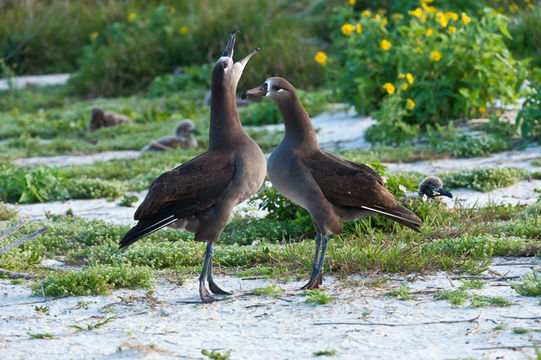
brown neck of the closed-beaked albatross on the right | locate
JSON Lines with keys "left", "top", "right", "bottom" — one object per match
{"left": 277, "top": 95, "right": 319, "bottom": 149}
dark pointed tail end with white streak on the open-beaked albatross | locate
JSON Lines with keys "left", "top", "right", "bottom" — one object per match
{"left": 120, "top": 205, "right": 199, "bottom": 249}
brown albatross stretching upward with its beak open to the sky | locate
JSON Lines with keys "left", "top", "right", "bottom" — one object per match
{"left": 120, "top": 31, "right": 266, "bottom": 303}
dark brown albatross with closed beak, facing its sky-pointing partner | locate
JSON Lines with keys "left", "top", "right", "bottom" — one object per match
{"left": 243, "top": 77, "right": 423, "bottom": 289}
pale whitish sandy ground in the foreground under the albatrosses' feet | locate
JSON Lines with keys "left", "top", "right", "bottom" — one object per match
{"left": 0, "top": 258, "right": 541, "bottom": 359}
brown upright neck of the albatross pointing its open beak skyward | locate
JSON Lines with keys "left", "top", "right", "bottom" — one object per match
{"left": 209, "top": 86, "right": 243, "bottom": 150}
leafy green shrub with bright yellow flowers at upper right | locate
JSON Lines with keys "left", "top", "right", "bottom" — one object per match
{"left": 326, "top": 0, "right": 526, "bottom": 143}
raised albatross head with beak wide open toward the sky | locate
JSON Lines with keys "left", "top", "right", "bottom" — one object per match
{"left": 212, "top": 30, "right": 259, "bottom": 89}
